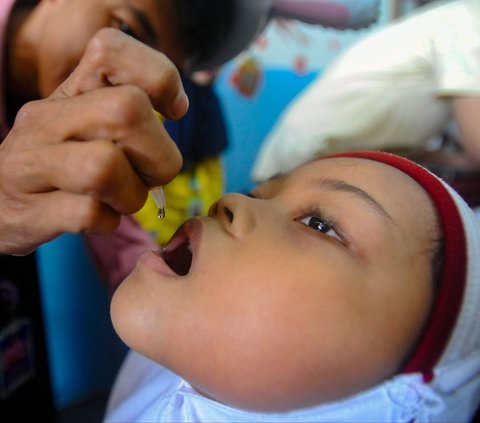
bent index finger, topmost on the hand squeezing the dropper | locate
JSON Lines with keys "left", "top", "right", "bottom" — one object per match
{"left": 50, "top": 28, "right": 188, "bottom": 119}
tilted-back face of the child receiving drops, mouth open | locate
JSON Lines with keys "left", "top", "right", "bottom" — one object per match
{"left": 112, "top": 158, "right": 438, "bottom": 410}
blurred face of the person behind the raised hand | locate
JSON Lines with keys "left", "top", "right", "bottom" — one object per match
{"left": 37, "top": 0, "right": 185, "bottom": 97}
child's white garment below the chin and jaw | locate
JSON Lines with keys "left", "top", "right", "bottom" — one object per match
{"left": 105, "top": 351, "right": 444, "bottom": 423}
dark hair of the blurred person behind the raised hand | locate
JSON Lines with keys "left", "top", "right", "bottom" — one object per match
{"left": 173, "top": 0, "right": 235, "bottom": 71}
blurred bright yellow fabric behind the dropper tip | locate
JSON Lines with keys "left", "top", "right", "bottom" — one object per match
{"left": 134, "top": 157, "right": 224, "bottom": 244}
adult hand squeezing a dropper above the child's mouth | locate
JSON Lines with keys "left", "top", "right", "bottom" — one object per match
{"left": 0, "top": 29, "right": 188, "bottom": 255}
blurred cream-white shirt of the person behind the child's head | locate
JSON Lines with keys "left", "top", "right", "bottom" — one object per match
{"left": 252, "top": 0, "right": 480, "bottom": 181}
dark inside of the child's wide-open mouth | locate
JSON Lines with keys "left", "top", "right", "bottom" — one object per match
{"left": 160, "top": 225, "right": 193, "bottom": 276}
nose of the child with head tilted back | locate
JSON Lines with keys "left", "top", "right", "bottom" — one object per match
{"left": 208, "top": 194, "right": 255, "bottom": 237}
